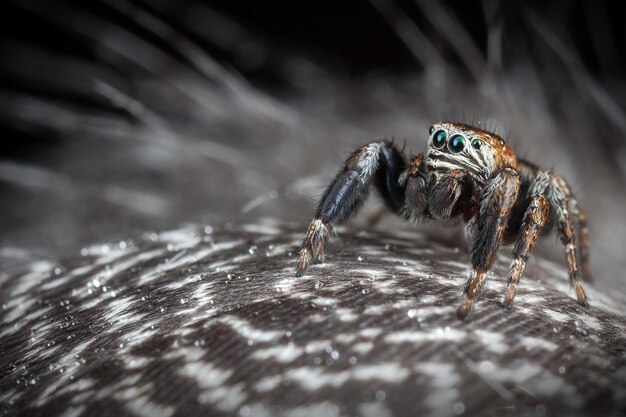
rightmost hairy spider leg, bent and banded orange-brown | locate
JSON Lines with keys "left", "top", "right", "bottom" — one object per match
{"left": 531, "top": 171, "right": 589, "bottom": 307}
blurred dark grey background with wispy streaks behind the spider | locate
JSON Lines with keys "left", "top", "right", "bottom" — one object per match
{"left": 0, "top": 0, "right": 626, "bottom": 290}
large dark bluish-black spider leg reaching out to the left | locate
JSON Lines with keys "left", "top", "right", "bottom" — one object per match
{"left": 296, "top": 140, "right": 405, "bottom": 276}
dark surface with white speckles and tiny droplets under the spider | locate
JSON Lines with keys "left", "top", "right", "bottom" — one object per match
{"left": 0, "top": 222, "right": 626, "bottom": 417}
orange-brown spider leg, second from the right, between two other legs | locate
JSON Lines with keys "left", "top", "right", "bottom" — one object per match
{"left": 503, "top": 195, "right": 550, "bottom": 308}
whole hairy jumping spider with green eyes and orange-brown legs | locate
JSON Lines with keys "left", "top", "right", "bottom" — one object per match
{"left": 297, "top": 122, "right": 588, "bottom": 318}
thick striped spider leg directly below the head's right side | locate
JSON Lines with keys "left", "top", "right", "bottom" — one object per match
{"left": 457, "top": 168, "right": 520, "bottom": 319}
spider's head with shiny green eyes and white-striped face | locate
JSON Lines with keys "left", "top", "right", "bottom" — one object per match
{"left": 426, "top": 122, "right": 517, "bottom": 180}
